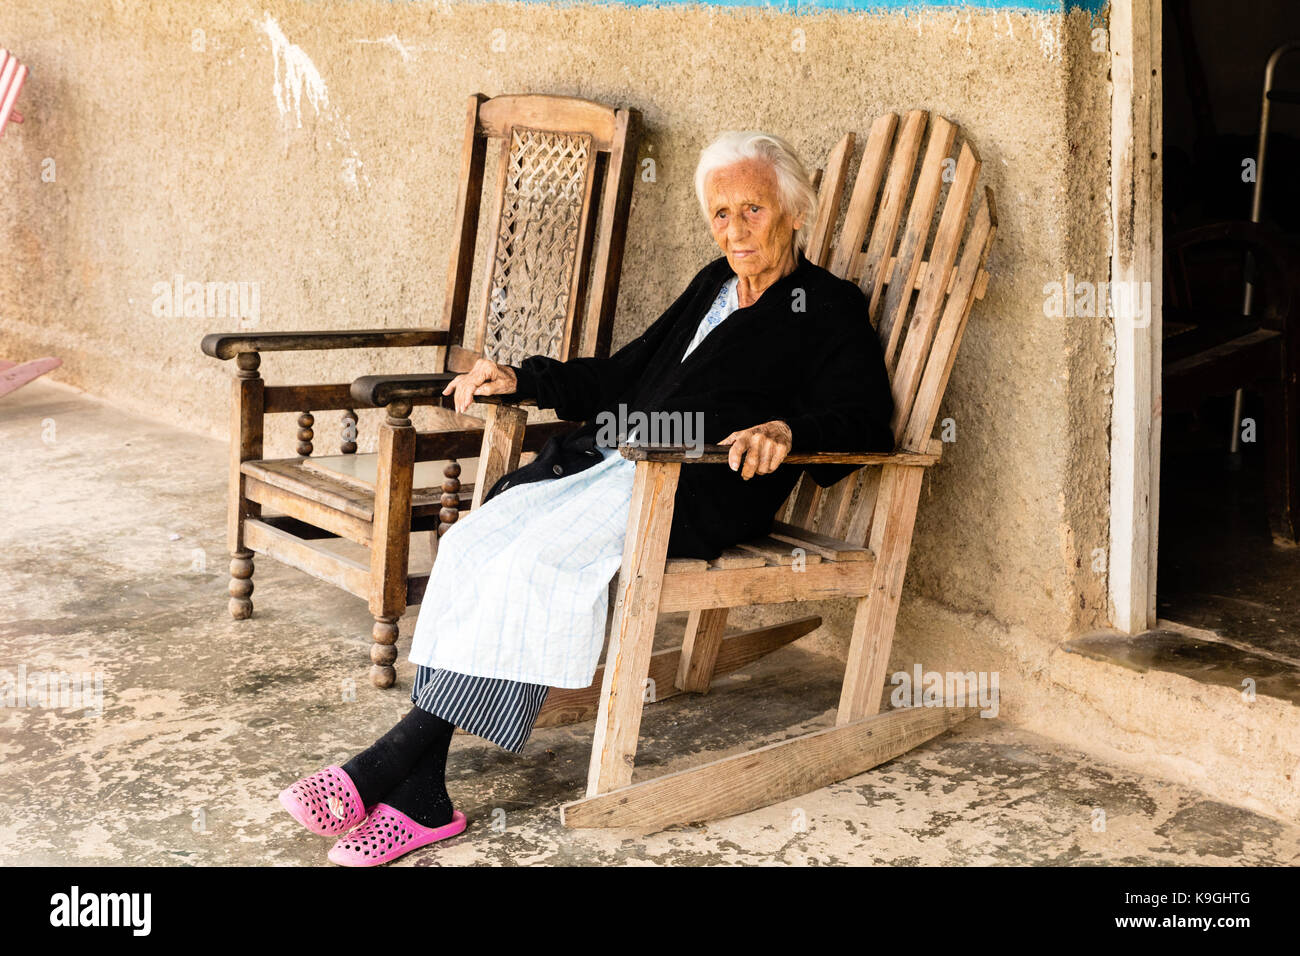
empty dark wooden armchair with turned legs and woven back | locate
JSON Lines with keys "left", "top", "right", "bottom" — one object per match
{"left": 202, "top": 94, "right": 640, "bottom": 687}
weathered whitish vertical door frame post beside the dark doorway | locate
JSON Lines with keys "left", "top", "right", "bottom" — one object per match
{"left": 1109, "top": 0, "right": 1164, "bottom": 633}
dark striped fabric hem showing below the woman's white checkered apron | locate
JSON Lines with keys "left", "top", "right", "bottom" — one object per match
{"left": 411, "top": 665, "right": 551, "bottom": 753}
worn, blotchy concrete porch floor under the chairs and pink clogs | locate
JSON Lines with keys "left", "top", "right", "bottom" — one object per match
{"left": 0, "top": 382, "right": 1300, "bottom": 866}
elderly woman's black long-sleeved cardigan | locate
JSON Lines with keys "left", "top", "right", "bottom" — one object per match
{"left": 493, "top": 254, "right": 893, "bottom": 558}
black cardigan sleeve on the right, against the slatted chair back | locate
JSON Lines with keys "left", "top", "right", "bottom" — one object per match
{"left": 785, "top": 284, "right": 894, "bottom": 455}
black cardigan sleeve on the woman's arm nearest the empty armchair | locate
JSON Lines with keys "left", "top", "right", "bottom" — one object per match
{"left": 515, "top": 267, "right": 709, "bottom": 421}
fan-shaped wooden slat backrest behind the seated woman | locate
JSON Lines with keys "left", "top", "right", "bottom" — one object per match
{"left": 784, "top": 109, "right": 997, "bottom": 544}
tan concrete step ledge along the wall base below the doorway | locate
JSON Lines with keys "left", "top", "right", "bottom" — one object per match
{"left": 889, "top": 597, "right": 1300, "bottom": 822}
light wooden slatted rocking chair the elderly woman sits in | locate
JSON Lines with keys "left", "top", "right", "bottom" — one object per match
{"left": 481, "top": 111, "right": 996, "bottom": 829}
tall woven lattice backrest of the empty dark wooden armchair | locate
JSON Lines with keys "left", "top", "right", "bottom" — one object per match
{"left": 446, "top": 94, "right": 638, "bottom": 371}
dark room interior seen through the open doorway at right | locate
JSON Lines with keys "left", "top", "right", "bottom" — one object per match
{"left": 1157, "top": 0, "right": 1300, "bottom": 679}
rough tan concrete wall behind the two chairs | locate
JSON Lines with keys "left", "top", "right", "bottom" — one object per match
{"left": 0, "top": 0, "right": 1110, "bottom": 649}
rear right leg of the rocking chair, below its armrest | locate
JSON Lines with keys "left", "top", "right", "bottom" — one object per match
{"left": 835, "top": 464, "right": 926, "bottom": 726}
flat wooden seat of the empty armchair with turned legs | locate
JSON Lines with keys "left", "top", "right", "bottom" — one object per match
{"left": 239, "top": 454, "right": 478, "bottom": 522}
